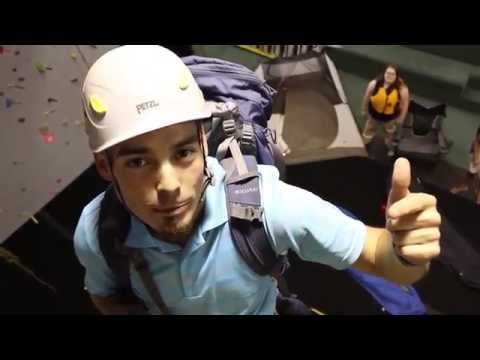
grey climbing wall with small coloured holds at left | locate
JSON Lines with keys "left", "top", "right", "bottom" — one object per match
{"left": 0, "top": 45, "right": 115, "bottom": 243}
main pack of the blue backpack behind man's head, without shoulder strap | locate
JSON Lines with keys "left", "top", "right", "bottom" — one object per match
{"left": 183, "top": 56, "right": 285, "bottom": 176}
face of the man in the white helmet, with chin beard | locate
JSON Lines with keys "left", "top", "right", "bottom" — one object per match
{"left": 103, "top": 122, "right": 204, "bottom": 241}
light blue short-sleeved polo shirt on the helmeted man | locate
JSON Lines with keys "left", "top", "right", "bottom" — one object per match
{"left": 75, "top": 158, "right": 366, "bottom": 315}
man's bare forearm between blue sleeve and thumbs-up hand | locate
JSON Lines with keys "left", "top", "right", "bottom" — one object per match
{"left": 375, "top": 229, "right": 429, "bottom": 285}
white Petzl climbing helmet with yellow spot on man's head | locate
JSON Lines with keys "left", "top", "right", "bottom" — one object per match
{"left": 82, "top": 45, "right": 211, "bottom": 153}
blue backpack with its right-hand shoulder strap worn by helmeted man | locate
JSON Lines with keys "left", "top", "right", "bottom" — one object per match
{"left": 184, "top": 56, "right": 312, "bottom": 314}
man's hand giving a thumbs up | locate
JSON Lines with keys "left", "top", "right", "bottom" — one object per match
{"left": 386, "top": 158, "right": 441, "bottom": 265}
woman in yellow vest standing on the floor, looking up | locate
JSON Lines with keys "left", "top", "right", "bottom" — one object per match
{"left": 362, "top": 65, "right": 410, "bottom": 155}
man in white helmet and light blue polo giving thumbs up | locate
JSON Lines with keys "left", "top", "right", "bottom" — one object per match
{"left": 75, "top": 46, "right": 440, "bottom": 314}
